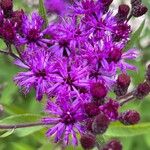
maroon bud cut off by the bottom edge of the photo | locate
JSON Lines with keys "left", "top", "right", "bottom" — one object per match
{"left": 102, "top": 140, "right": 122, "bottom": 150}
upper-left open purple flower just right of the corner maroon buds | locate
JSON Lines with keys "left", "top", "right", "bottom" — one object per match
{"left": 18, "top": 13, "right": 50, "bottom": 47}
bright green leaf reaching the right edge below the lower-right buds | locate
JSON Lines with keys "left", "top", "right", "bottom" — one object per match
{"left": 105, "top": 122, "right": 150, "bottom": 137}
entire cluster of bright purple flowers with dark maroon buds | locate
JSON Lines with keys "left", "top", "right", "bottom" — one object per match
{"left": 0, "top": 0, "right": 150, "bottom": 150}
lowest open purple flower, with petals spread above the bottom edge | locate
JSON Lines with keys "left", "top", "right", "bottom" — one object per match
{"left": 42, "top": 92, "right": 84, "bottom": 145}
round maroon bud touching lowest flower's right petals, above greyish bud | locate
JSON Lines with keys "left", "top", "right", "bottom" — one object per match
{"left": 84, "top": 103, "right": 100, "bottom": 117}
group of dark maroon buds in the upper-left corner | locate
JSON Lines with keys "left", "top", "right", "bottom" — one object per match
{"left": 0, "top": 0, "right": 24, "bottom": 43}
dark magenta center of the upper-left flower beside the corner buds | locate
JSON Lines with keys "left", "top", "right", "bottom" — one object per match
{"left": 27, "top": 29, "right": 39, "bottom": 42}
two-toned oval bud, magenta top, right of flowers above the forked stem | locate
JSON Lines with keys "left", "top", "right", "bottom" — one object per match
{"left": 114, "top": 73, "right": 131, "bottom": 96}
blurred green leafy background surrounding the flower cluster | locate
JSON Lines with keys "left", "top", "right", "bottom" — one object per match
{"left": 0, "top": 0, "right": 150, "bottom": 150}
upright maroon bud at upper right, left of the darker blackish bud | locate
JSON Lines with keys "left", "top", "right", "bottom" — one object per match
{"left": 116, "top": 4, "right": 130, "bottom": 22}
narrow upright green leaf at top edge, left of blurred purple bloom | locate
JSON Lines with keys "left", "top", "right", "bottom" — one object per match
{"left": 39, "top": 0, "right": 48, "bottom": 29}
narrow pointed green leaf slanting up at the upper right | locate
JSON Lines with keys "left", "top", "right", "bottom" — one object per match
{"left": 125, "top": 20, "right": 145, "bottom": 50}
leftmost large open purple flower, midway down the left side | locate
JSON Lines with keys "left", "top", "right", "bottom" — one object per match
{"left": 14, "top": 47, "right": 53, "bottom": 101}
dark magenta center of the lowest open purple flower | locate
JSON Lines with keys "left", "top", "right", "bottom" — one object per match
{"left": 62, "top": 111, "right": 75, "bottom": 124}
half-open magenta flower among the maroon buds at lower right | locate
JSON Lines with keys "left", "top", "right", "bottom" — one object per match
{"left": 99, "top": 99, "right": 119, "bottom": 121}
